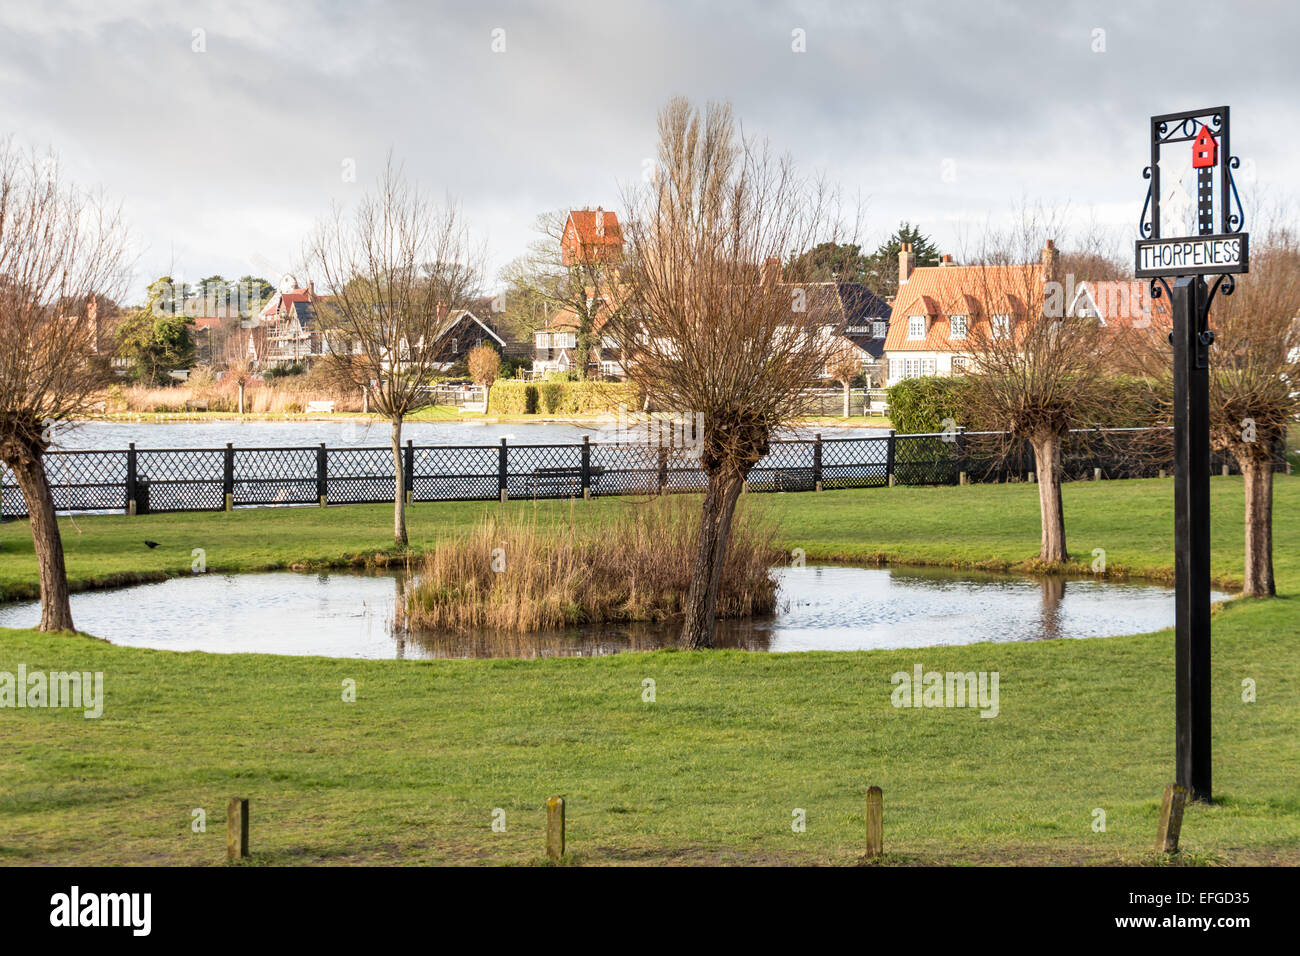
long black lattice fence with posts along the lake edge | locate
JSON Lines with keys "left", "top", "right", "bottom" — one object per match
{"left": 0, "top": 428, "right": 1286, "bottom": 518}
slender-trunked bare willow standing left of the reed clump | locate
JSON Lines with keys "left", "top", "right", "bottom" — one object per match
{"left": 306, "top": 160, "right": 482, "bottom": 545}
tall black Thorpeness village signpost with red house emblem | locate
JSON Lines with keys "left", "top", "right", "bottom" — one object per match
{"left": 1134, "top": 107, "right": 1249, "bottom": 801}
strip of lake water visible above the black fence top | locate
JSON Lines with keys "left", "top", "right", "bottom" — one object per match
{"left": 53, "top": 419, "right": 889, "bottom": 450}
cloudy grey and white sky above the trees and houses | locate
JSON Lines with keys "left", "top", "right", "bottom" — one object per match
{"left": 0, "top": 0, "right": 1300, "bottom": 300}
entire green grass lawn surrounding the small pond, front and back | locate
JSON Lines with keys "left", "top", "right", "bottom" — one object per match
{"left": 0, "top": 476, "right": 1300, "bottom": 865}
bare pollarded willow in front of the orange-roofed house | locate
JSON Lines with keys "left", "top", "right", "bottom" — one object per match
{"left": 967, "top": 221, "right": 1141, "bottom": 564}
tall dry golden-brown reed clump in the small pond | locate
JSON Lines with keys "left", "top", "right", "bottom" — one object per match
{"left": 407, "top": 497, "right": 783, "bottom": 632}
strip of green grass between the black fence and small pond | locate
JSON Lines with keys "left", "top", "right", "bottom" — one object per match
{"left": 0, "top": 475, "right": 1300, "bottom": 600}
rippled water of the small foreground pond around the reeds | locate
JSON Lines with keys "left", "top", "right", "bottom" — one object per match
{"left": 0, "top": 566, "right": 1225, "bottom": 658}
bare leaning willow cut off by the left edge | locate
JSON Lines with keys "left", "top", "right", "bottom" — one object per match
{"left": 0, "top": 140, "right": 127, "bottom": 631}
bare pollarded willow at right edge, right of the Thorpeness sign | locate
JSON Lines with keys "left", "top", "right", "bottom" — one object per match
{"left": 1209, "top": 229, "right": 1300, "bottom": 597}
